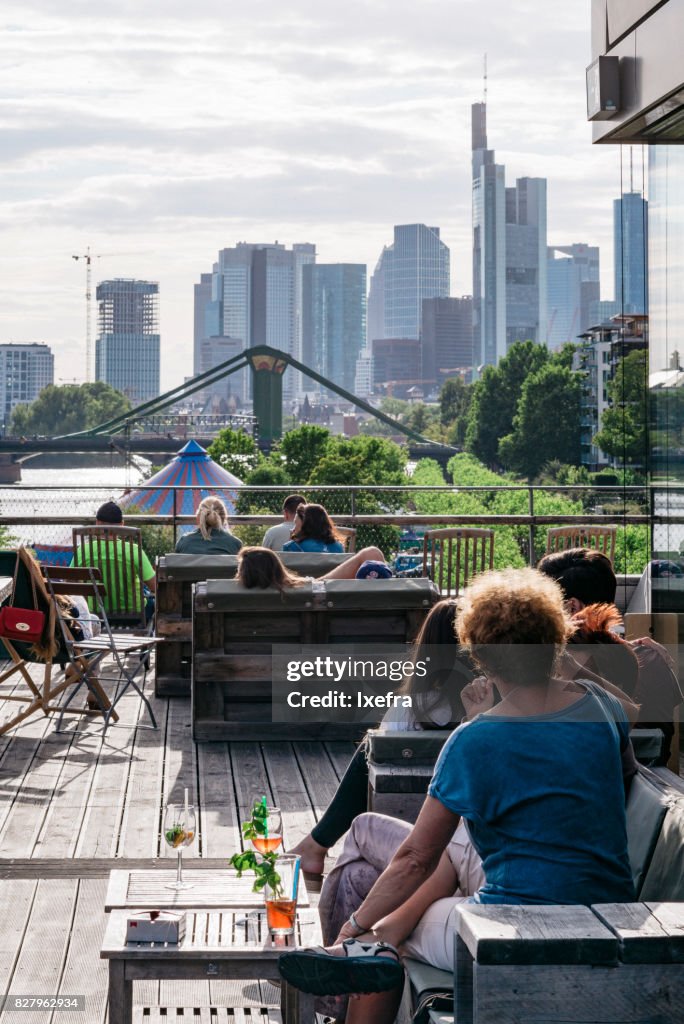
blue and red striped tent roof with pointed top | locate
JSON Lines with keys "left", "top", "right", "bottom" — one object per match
{"left": 119, "top": 441, "right": 243, "bottom": 515}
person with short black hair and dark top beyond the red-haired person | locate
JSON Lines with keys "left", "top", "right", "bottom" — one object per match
{"left": 538, "top": 548, "right": 682, "bottom": 765}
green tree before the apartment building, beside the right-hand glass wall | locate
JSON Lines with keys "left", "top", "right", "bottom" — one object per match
{"left": 594, "top": 349, "right": 648, "bottom": 464}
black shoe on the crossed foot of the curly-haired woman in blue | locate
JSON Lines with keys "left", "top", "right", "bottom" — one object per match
{"left": 277, "top": 939, "right": 403, "bottom": 995}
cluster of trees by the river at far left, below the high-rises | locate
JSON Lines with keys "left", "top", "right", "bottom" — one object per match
{"left": 10, "top": 381, "right": 131, "bottom": 436}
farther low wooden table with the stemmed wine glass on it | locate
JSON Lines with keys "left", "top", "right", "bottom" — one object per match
{"left": 104, "top": 860, "right": 309, "bottom": 912}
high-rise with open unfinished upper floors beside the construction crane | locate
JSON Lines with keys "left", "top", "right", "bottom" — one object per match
{"left": 95, "top": 278, "right": 160, "bottom": 406}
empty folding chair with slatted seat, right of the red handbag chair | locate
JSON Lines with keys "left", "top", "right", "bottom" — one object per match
{"left": 42, "top": 565, "right": 158, "bottom": 732}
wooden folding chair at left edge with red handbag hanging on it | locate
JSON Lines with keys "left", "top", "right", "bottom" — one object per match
{"left": 0, "top": 548, "right": 118, "bottom": 735}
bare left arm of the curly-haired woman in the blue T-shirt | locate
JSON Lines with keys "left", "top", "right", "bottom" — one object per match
{"left": 340, "top": 797, "right": 460, "bottom": 939}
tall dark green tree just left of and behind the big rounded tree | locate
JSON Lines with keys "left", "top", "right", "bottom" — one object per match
{"left": 465, "top": 341, "right": 549, "bottom": 466}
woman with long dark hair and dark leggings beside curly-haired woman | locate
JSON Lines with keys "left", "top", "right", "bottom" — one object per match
{"left": 292, "top": 598, "right": 474, "bottom": 874}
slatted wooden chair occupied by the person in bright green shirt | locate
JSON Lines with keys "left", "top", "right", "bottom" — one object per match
{"left": 72, "top": 526, "right": 146, "bottom": 631}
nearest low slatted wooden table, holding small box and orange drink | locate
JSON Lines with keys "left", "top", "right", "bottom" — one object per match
{"left": 100, "top": 907, "right": 322, "bottom": 1024}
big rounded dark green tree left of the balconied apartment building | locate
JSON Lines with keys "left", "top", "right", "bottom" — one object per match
{"left": 499, "top": 362, "right": 582, "bottom": 479}
